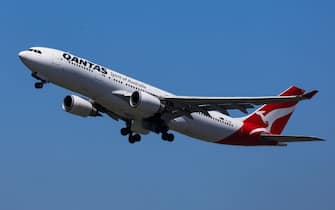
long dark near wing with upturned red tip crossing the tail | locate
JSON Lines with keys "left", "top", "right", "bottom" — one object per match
{"left": 161, "top": 90, "right": 318, "bottom": 117}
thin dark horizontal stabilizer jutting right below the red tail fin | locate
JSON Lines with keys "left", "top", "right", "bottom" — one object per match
{"left": 260, "top": 134, "right": 324, "bottom": 142}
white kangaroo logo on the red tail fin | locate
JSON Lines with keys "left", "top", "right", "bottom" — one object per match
{"left": 249, "top": 106, "right": 294, "bottom": 135}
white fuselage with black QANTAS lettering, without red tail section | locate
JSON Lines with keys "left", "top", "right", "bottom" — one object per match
{"left": 20, "top": 47, "right": 243, "bottom": 142}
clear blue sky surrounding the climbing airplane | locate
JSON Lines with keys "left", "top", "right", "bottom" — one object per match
{"left": 0, "top": 0, "right": 335, "bottom": 210}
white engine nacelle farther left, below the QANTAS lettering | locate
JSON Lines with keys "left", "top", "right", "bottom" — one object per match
{"left": 62, "top": 95, "right": 101, "bottom": 117}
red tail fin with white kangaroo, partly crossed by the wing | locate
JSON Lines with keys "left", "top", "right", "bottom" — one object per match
{"left": 243, "top": 86, "right": 305, "bottom": 134}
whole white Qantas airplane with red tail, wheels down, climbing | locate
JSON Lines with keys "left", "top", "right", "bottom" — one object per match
{"left": 18, "top": 47, "right": 323, "bottom": 146}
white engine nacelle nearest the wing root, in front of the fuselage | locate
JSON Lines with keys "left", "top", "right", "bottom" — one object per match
{"left": 129, "top": 91, "right": 162, "bottom": 119}
